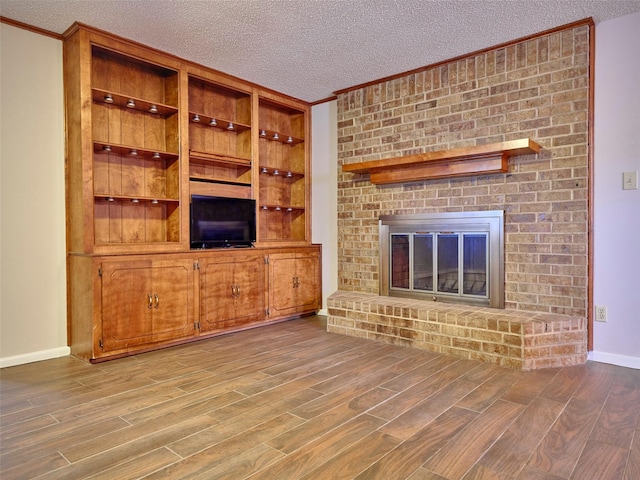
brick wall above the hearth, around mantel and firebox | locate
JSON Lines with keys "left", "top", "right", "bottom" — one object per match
{"left": 338, "top": 25, "right": 589, "bottom": 316}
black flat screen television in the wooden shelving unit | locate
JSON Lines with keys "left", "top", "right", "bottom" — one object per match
{"left": 191, "top": 195, "right": 256, "bottom": 249}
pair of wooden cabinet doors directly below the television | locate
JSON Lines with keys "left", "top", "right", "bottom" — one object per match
{"left": 199, "top": 255, "right": 265, "bottom": 333}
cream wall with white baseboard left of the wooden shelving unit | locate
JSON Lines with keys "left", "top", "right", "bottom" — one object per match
{"left": 0, "top": 23, "right": 69, "bottom": 367}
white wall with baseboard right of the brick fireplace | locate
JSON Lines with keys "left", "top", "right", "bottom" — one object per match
{"left": 590, "top": 12, "right": 640, "bottom": 368}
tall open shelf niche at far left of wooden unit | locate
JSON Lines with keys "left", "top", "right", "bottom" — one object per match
{"left": 91, "top": 45, "right": 181, "bottom": 247}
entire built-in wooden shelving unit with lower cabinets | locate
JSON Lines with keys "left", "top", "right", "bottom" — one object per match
{"left": 64, "top": 24, "right": 322, "bottom": 362}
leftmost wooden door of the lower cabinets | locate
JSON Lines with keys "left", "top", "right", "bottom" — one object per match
{"left": 102, "top": 260, "right": 153, "bottom": 352}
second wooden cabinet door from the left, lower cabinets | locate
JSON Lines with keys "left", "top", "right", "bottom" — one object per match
{"left": 151, "top": 260, "right": 195, "bottom": 342}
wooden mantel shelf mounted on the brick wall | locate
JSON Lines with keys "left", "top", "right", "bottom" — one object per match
{"left": 342, "top": 138, "right": 540, "bottom": 185}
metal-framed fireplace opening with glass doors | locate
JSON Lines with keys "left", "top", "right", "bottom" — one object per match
{"left": 379, "top": 210, "right": 504, "bottom": 308}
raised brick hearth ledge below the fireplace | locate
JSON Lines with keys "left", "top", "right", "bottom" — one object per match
{"left": 327, "top": 291, "right": 587, "bottom": 370}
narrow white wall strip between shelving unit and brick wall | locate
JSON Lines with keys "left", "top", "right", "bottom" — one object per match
{"left": 311, "top": 100, "right": 338, "bottom": 315}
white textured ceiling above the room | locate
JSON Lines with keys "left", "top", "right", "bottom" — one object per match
{"left": 0, "top": 0, "right": 640, "bottom": 102}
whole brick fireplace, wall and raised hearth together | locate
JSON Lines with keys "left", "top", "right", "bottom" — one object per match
{"left": 327, "top": 23, "right": 590, "bottom": 369}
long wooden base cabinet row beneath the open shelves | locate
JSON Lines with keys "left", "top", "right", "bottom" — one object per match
{"left": 69, "top": 246, "right": 321, "bottom": 361}
